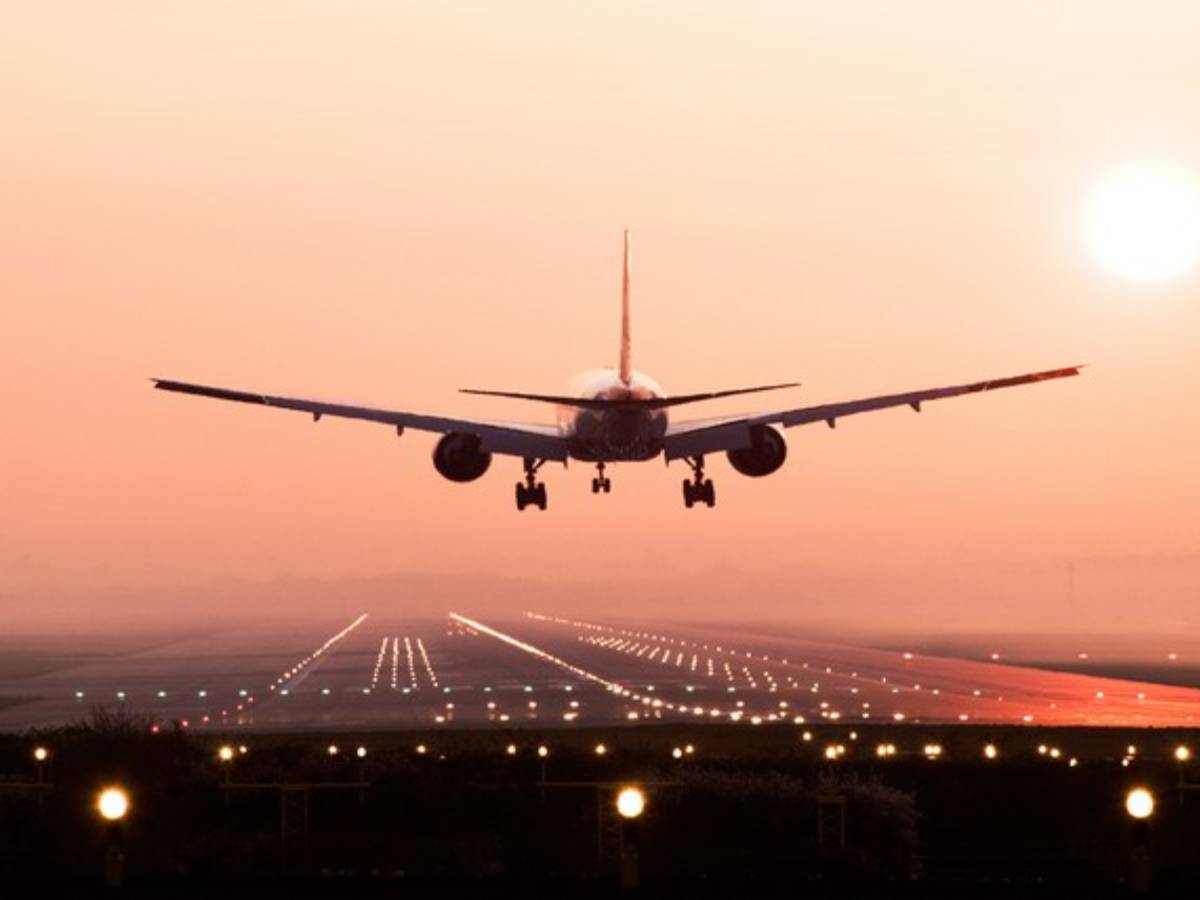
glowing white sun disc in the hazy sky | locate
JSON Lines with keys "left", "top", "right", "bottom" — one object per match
{"left": 1082, "top": 161, "right": 1200, "bottom": 282}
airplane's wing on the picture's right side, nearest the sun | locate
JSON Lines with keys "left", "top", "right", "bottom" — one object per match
{"left": 664, "top": 366, "right": 1082, "bottom": 460}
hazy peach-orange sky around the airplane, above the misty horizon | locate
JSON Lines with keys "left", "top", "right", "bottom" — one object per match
{"left": 7, "top": 0, "right": 1200, "bottom": 628}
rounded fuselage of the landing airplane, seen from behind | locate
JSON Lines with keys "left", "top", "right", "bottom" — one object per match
{"left": 557, "top": 368, "right": 667, "bottom": 462}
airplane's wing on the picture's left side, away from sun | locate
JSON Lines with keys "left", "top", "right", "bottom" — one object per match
{"left": 152, "top": 378, "right": 566, "bottom": 461}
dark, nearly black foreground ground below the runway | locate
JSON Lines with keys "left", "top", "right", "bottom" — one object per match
{"left": 0, "top": 714, "right": 1200, "bottom": 898}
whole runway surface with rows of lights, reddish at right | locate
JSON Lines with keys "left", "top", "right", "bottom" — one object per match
{"left": 0, "top": 612, "right": 1200, "bottom": 731}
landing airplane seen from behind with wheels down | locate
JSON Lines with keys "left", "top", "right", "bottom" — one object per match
{"left": 151, "top": 230, "right": 1082, "bottom": 510}
